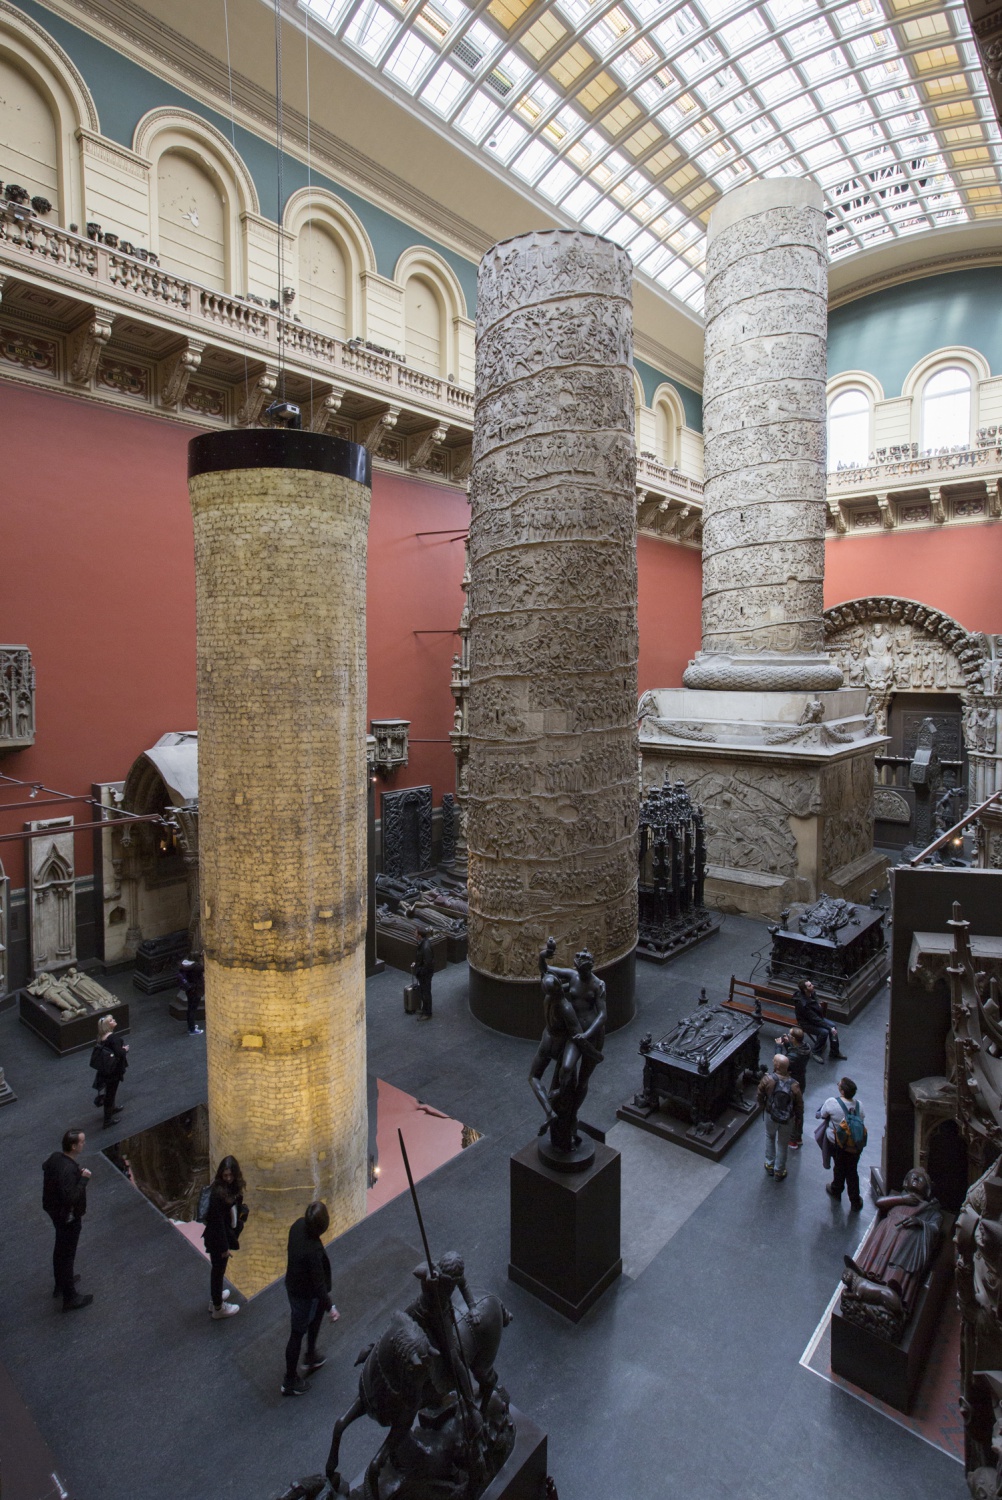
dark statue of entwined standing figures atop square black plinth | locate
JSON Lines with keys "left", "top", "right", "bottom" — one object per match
{"left": 530, "top": 938, "right": 606, "bottom": 1170}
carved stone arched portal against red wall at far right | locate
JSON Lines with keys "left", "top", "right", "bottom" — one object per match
{"left": 825, "top": 594, "right": 1002, "bottom": 806}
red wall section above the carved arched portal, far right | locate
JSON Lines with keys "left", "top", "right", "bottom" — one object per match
{"left": 825, "top": 525, "right": 1002, "bottom": 632}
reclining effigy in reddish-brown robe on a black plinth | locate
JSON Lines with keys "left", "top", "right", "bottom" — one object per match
{"left": 842, "top": 1169, "right": 944, "bottom": 1340}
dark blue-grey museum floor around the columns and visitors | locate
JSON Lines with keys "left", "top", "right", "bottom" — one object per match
{"left": 0, "top": 918, "right": 968, "bottom": 1500}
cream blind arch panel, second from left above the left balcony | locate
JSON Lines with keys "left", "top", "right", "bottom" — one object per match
{"left": 158, "top": 150, "right": 227, "bottom": 291}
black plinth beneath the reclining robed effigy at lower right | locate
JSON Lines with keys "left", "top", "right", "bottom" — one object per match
{"left": 831, "top": 1217, "right": 954, "bottom": 1415}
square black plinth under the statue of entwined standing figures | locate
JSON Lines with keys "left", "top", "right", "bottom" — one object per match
{"left": 509, "top": 1142, "right": 623, "bottom": 1323}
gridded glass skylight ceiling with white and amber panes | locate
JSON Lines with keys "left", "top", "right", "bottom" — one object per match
{"left": 297, "top": 0, "right": 1002, "bottom": 312}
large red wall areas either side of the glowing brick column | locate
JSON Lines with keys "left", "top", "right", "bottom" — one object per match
{"left": 0, "top": 384, "right": 470, "bottom": 888}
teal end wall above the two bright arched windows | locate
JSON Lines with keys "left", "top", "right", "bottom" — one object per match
{"left": 828, "top": 266, "right": 1002, "bottom": 398}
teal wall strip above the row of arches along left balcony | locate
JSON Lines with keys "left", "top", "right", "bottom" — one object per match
{"left": 18, "top": 0, "right": 702, "bottom": 414}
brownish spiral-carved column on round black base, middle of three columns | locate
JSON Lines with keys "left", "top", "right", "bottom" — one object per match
{"left": 467, "top": 230, "right": 638, "bottom": 1037}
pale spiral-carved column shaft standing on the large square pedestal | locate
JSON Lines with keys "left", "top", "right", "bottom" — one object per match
{"left": 684, "top": 185, "right": 840, "bottom": 690}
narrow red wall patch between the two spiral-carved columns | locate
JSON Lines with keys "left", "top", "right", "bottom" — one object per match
{"left": 636, "top": 536, "right": 702, "bottom": 693}
